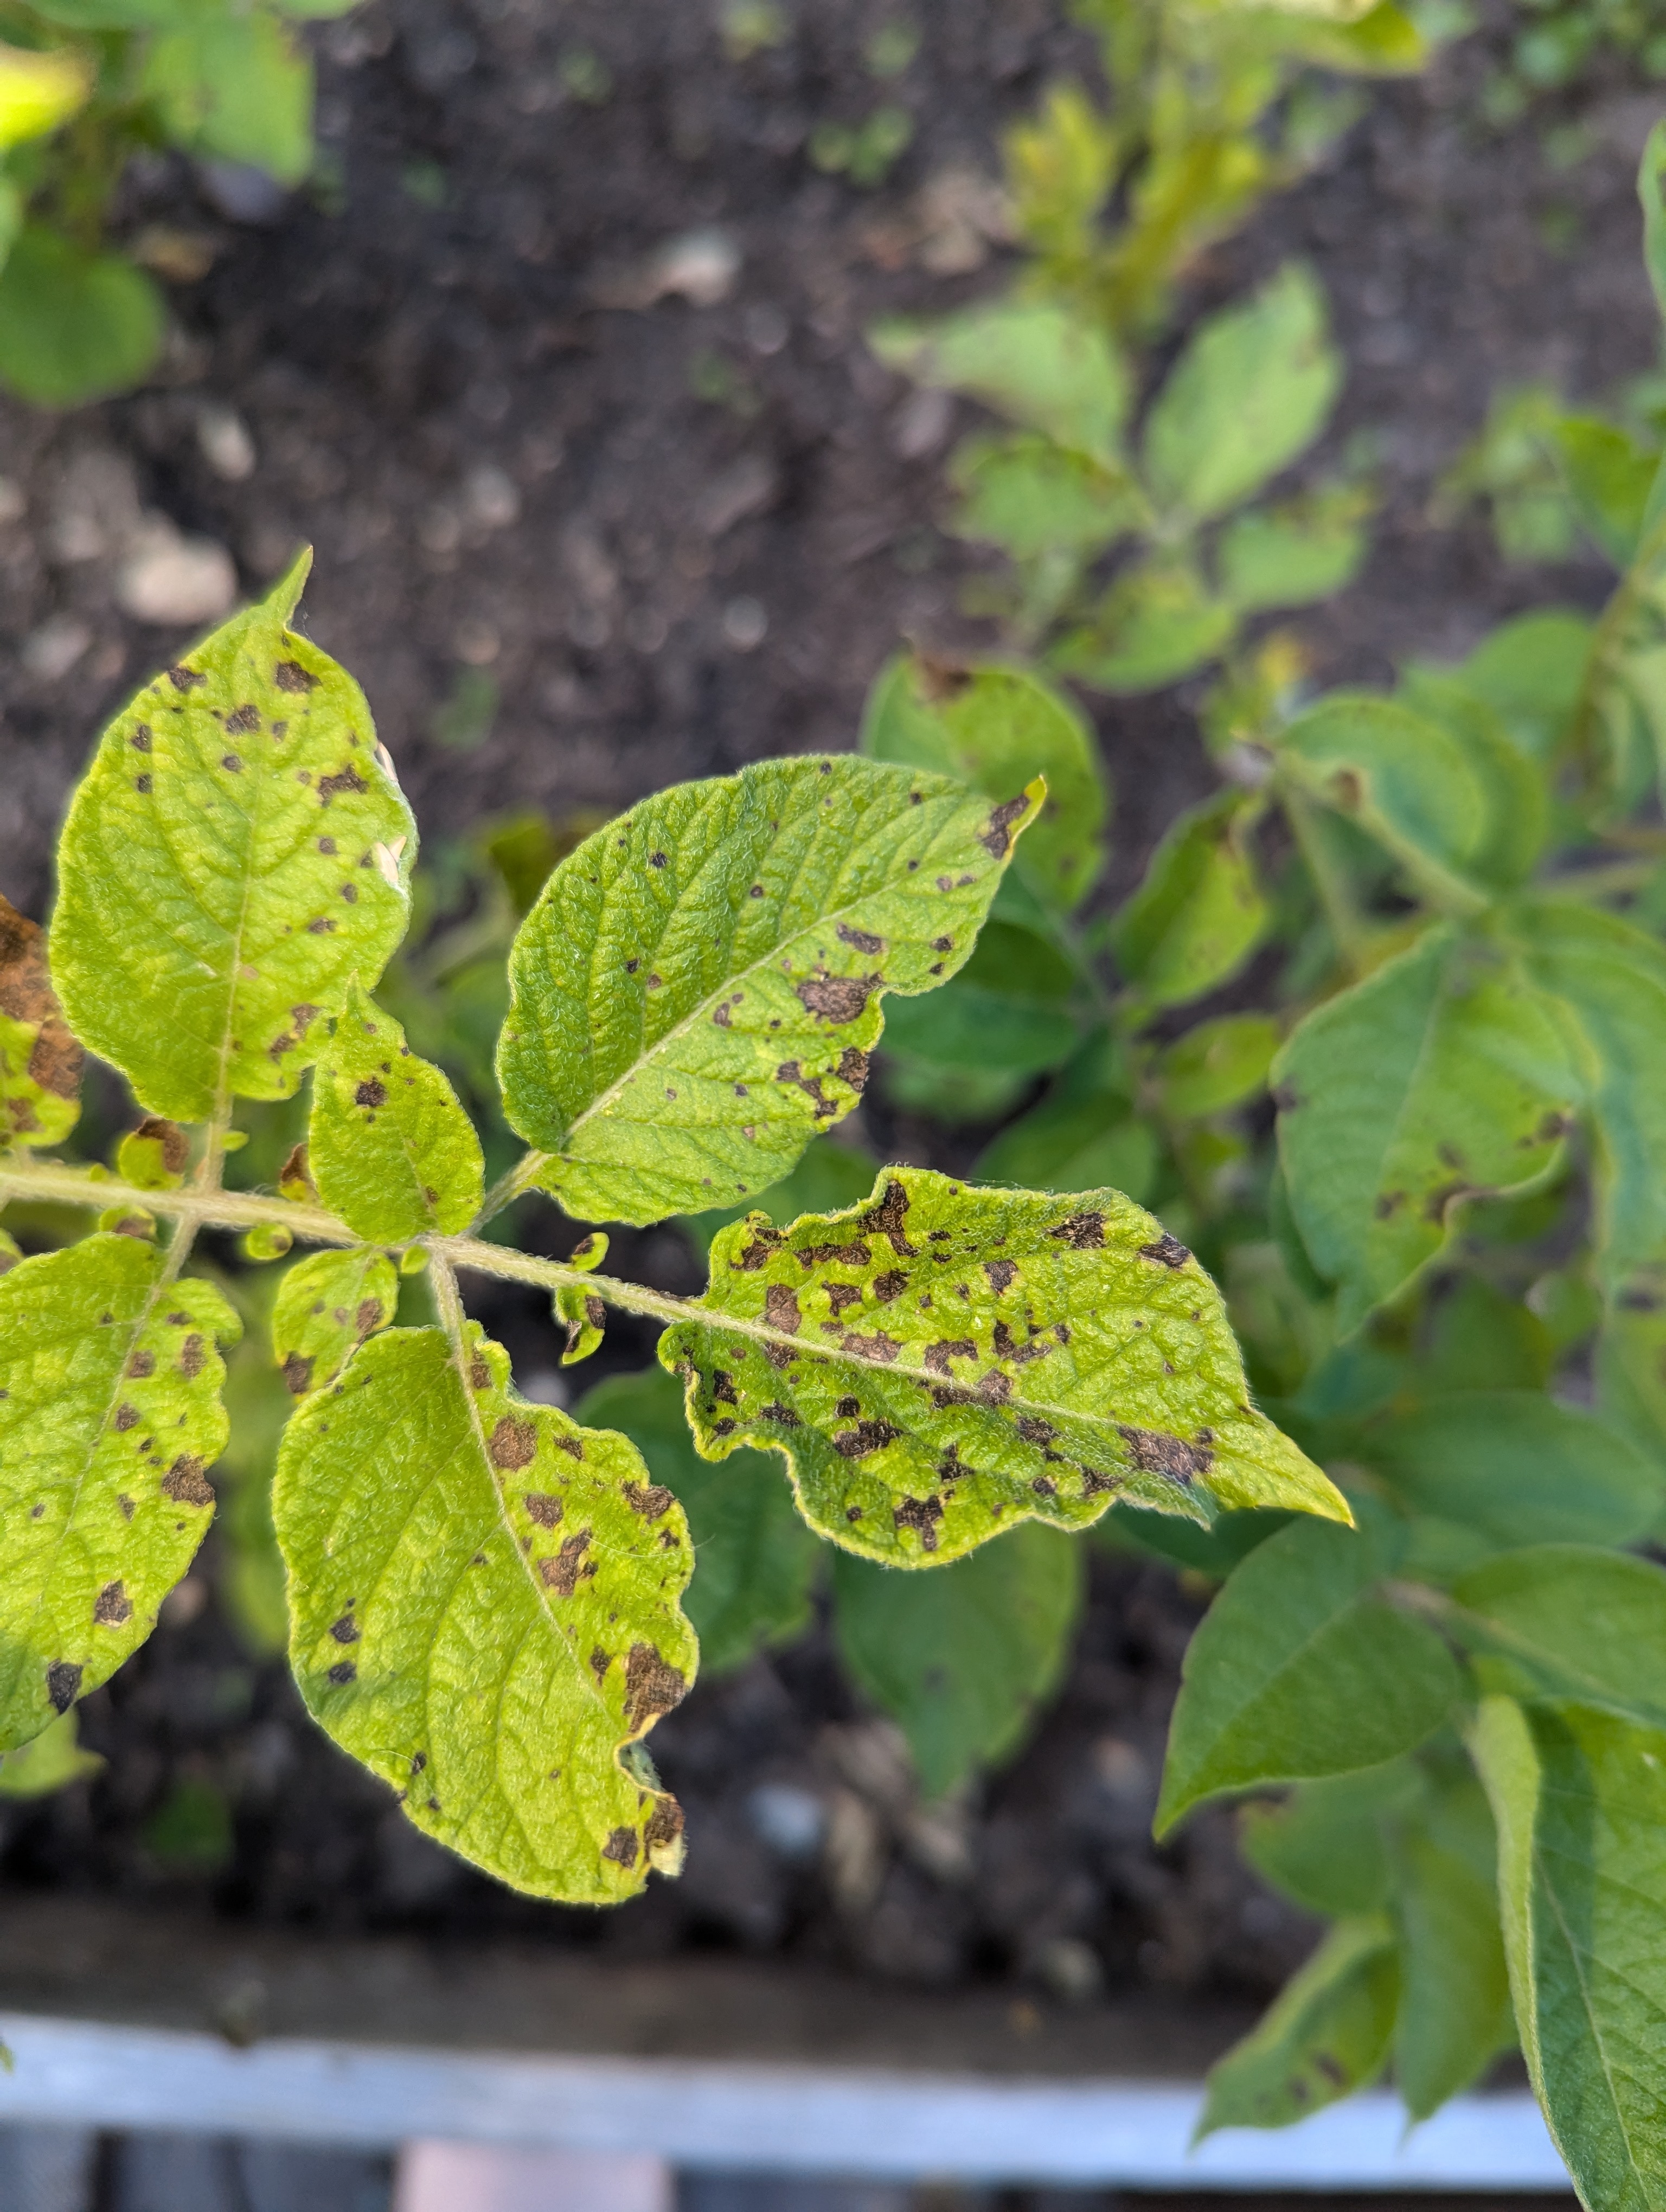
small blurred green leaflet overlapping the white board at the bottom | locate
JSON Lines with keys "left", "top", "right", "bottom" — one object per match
{"left": 1197, "top": 1913, "right": 1400, "bottom": 2137}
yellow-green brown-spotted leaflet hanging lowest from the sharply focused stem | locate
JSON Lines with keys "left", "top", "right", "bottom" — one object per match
{"left": 272, "top": 1323, "right": 697, "bottom": 1905}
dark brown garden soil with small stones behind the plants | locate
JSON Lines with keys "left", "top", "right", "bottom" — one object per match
{"left": 0, "top": 0, "right": 1655, "bottom": 2002}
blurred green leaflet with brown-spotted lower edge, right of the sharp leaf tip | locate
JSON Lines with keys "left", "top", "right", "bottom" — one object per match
{"left": 1272, "top": 927, "right": 1582, "bottom": 1334}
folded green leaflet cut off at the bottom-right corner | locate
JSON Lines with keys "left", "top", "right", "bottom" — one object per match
{"left": 1471, "top": 1696, "right": 1666, "bottom": 2212}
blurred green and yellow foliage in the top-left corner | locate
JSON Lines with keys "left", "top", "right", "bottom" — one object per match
{"left": 0, "top": 0, "right": 343, "bottom": 407}
